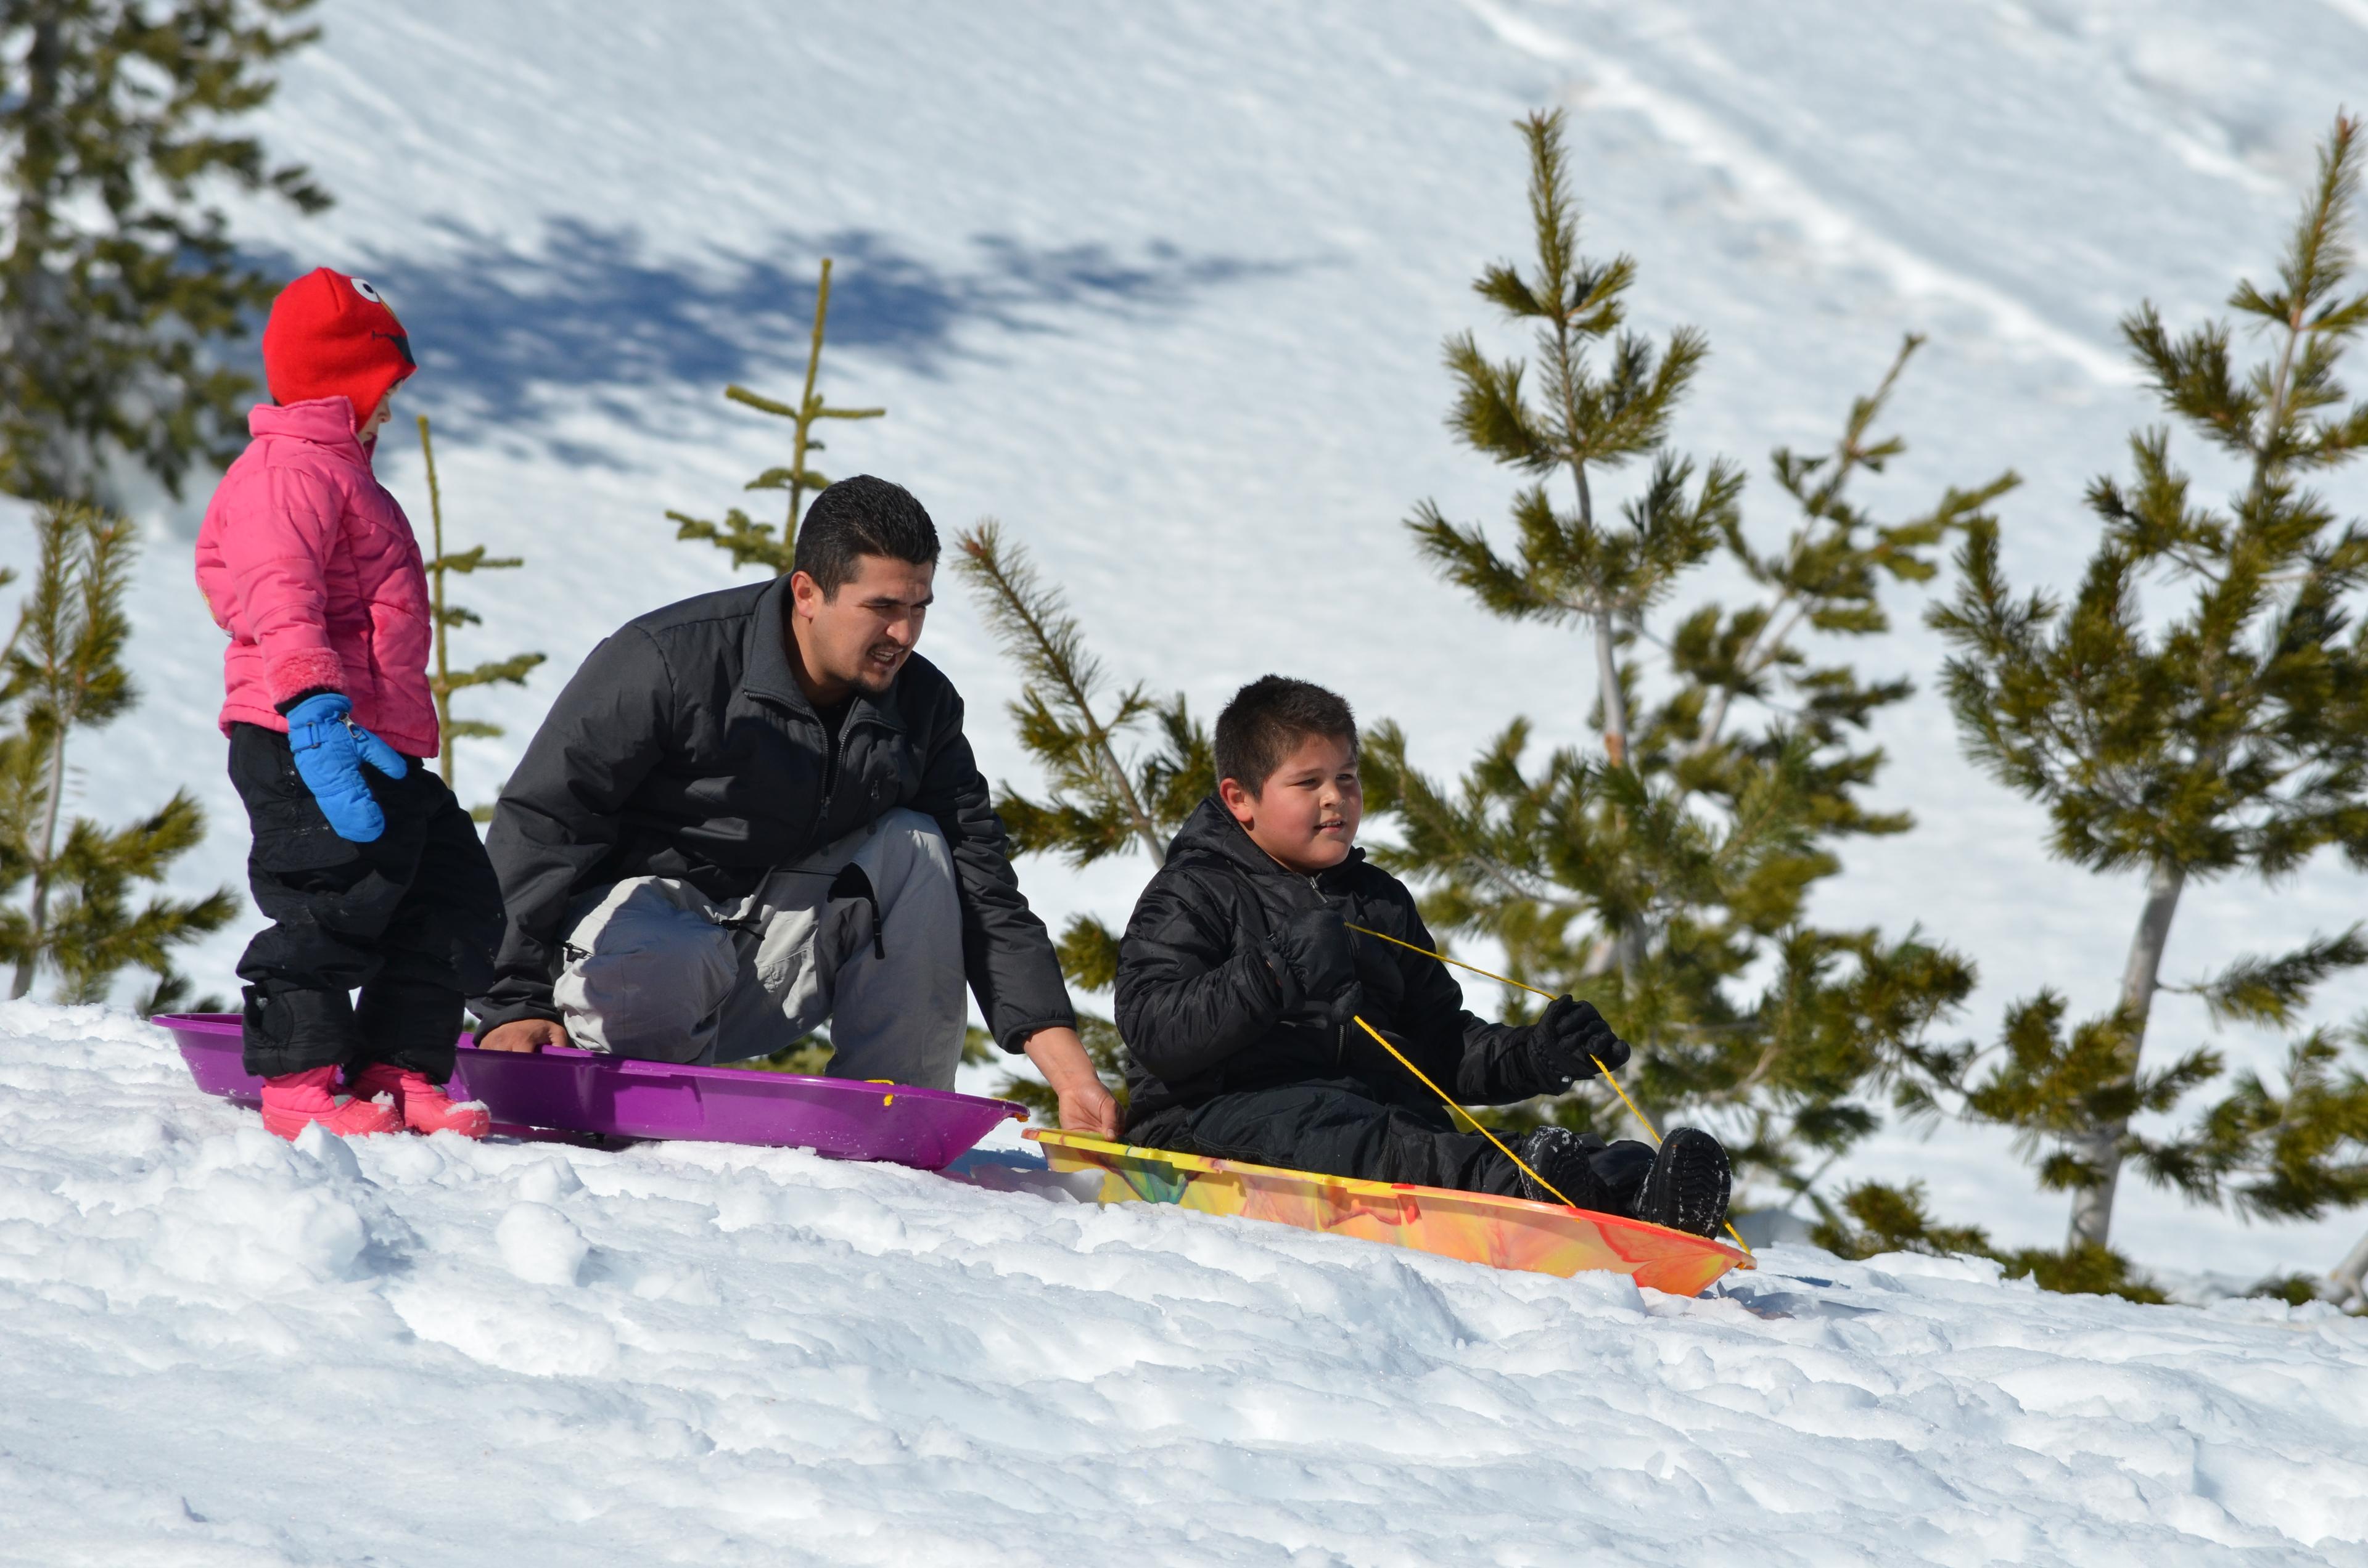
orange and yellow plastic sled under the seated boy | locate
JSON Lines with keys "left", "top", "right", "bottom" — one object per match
{"left": 1026, "top": 1128, "right": 1753, "bottom": 1295}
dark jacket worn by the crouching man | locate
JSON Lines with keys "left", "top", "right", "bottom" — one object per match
{"left": 476, "top": 578, "right": 1075, "bottom": 1052}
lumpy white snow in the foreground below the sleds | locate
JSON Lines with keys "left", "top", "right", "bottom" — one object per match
{"left": 0, "top": 1004, "right": 2368, "bottom": 1568}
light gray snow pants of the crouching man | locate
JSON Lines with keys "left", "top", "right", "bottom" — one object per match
{"left": 552, "top": 810, "right": 969, "bottom": 1090}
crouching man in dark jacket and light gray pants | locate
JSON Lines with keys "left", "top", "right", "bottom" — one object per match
{"left": 476, "top": 476, "right": 1117, "bottom": 1135}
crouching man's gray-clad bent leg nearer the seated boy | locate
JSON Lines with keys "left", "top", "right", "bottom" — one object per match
{"left": 725, "top": 810, "right": 969, "bottom": 1090}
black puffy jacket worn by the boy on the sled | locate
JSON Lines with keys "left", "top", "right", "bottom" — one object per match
{"left": 1117, "top": 798, "right": 1565, "bottom": 1128}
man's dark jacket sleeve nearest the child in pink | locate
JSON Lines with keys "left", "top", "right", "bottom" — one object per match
{"left": 476, "top": 625, "right": 673, "bottom": 1028}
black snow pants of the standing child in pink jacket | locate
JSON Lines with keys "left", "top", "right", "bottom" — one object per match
{"left": 229, "top": 724, "right": 502, "bottom": 1083}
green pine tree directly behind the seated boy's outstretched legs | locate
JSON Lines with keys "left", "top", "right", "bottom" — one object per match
{"left": 1367, "top": 113, "right": 2015, "bottom": 1208}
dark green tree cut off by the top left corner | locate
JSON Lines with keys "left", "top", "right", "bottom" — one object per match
{"left": 0, "top": 0, "right": 329, "bottom": 500}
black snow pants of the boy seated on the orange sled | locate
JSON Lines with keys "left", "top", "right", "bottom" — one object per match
{"left": 1127, "top": 1078, "right": 1653, "bottom": 1213}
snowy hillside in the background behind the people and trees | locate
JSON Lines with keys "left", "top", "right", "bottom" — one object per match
{"left": 9, "top": 0, "right": 2368, "bottom": 1275}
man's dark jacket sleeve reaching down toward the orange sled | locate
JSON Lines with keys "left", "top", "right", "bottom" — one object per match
{"left": 911, "top": 692, "right": 1077, "bottom": 1052}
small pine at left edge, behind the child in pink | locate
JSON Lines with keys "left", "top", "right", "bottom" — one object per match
{"left": 0, "top": 504, "right": 239, "bottom": 1011}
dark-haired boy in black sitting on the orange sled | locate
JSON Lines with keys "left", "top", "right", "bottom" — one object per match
{"left": 1117, "top": 675, "right": 1729, "bottom": 1236}
